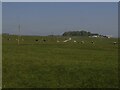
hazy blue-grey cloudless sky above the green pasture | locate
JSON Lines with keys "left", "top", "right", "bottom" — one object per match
{"left": 2, "top": 2, "right": 118, "bottom": 37}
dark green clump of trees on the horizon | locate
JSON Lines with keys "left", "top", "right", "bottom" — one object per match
{"left": 63, "top": 30, "right": 99, "bottom": 36}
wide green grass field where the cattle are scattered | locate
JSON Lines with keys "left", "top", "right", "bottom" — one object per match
{"left": 2, "top": 36, "right": 118, "bottom": 88}
